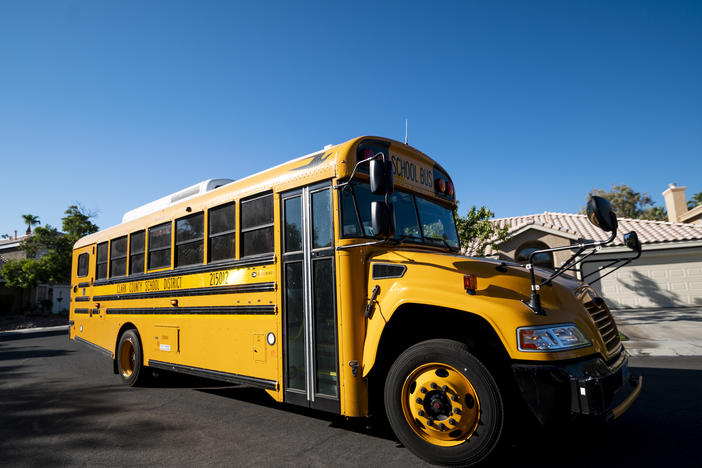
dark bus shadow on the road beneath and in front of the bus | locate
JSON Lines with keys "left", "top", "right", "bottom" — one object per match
{"left": 176, "top": 367, "right": 702, "bottom": 467}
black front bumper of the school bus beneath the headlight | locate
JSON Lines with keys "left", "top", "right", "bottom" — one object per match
{"left": 512, "top": 352, "right": 643, "bottom": 424}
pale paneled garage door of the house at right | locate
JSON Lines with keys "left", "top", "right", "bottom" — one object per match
{"left": 583, "top": 248, "right": 702, "bottom": 308}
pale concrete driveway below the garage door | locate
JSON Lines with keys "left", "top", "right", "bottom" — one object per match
{"left": 612, "top": 307, "right": 702, "bottom": 356}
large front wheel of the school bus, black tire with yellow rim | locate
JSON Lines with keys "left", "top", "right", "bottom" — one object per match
{"left": 384, "top": 339, "right": 504, "bottom": 466}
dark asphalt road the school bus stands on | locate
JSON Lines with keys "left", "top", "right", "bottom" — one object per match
{"left": 0, "top": 332, "right": 702, "bottom": 467}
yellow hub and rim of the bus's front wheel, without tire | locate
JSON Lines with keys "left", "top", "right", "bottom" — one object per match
{"left": 402, "top": 363, "right": 480, "bottom": 447}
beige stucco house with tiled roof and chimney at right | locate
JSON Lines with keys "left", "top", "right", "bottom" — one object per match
{"left": 486, "top": 185, "right": 702, "bottom": 308}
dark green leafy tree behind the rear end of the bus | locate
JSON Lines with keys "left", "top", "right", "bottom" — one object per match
{"left": 1, "top": 205, "right": 98, "bottom": 288}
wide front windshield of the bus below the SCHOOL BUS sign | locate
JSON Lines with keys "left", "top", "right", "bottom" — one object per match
{"left": 341, "top": 182, "right": 458, "bottom": 249}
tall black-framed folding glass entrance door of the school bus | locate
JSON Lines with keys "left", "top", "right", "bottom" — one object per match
{"left": 281, "top": 183, "right": 339, "bottom": 412}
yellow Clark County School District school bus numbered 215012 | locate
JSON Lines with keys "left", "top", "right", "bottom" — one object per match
{"left": 70, "top": 137, "right": 641, "bottom": 464}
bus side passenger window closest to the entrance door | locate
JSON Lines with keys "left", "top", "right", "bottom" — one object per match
{"left": 241, "top": 193, "right": 273, "bottom": 257}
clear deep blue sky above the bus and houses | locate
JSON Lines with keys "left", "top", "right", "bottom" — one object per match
{"left": 0, "top": 0, "right": 702, "bottom": 234}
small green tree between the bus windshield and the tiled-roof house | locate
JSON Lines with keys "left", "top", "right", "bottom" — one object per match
{"left": 454, "top": 205, "right": 509, "bottom": 256}
